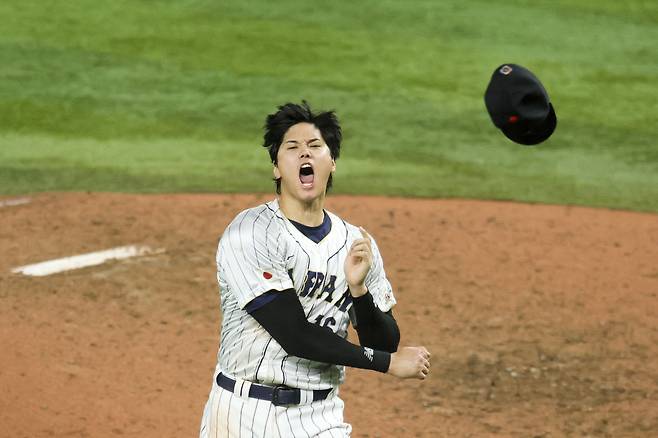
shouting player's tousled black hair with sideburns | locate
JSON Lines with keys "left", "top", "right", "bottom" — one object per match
{"left": 263, "top": 100, "right": 343, "bottom": 194}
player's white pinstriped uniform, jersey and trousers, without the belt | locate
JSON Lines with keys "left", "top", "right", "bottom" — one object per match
{"left": 200, "top": 200, "right": 395, "bottom": 438}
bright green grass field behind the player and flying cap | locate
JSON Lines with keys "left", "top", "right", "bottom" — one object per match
{"left": 0, "top": 0, "right": 658, "bottom": 212}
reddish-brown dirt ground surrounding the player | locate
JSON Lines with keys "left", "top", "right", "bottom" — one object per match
{"left": 0, "top": 194, "right": 658, "bottom": 437}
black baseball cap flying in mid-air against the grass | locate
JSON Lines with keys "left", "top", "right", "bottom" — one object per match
{"left": 484, "top": 64, "right": 557, "bottom": 146}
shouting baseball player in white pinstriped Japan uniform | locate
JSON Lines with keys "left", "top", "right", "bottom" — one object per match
{"left": 200, "top": 102, "right": 430, "bottom": 438}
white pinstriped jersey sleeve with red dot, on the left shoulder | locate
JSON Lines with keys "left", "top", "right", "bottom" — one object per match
{"left": 217, "top": 210, "right": 293, "bottom": 309}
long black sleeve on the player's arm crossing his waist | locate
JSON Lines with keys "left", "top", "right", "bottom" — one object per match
{"left": 250, "top": 289, "right": 391, "bottom": 373}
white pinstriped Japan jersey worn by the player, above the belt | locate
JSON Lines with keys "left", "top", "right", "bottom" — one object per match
{"left": 217, "top": 200, "right": 395, "bottom": 389}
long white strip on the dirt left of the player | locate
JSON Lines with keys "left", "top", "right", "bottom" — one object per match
{"left": 11, "top": 245, "right": 165, "bottom": 277}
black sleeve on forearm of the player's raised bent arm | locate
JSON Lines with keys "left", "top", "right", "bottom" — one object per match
{"left": 352, "top": 292, "right": 400, "bottom": 353}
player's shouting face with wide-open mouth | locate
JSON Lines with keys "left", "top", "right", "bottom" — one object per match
{"left": 274, "top": 123, "right": 336, "bottom": 202}
